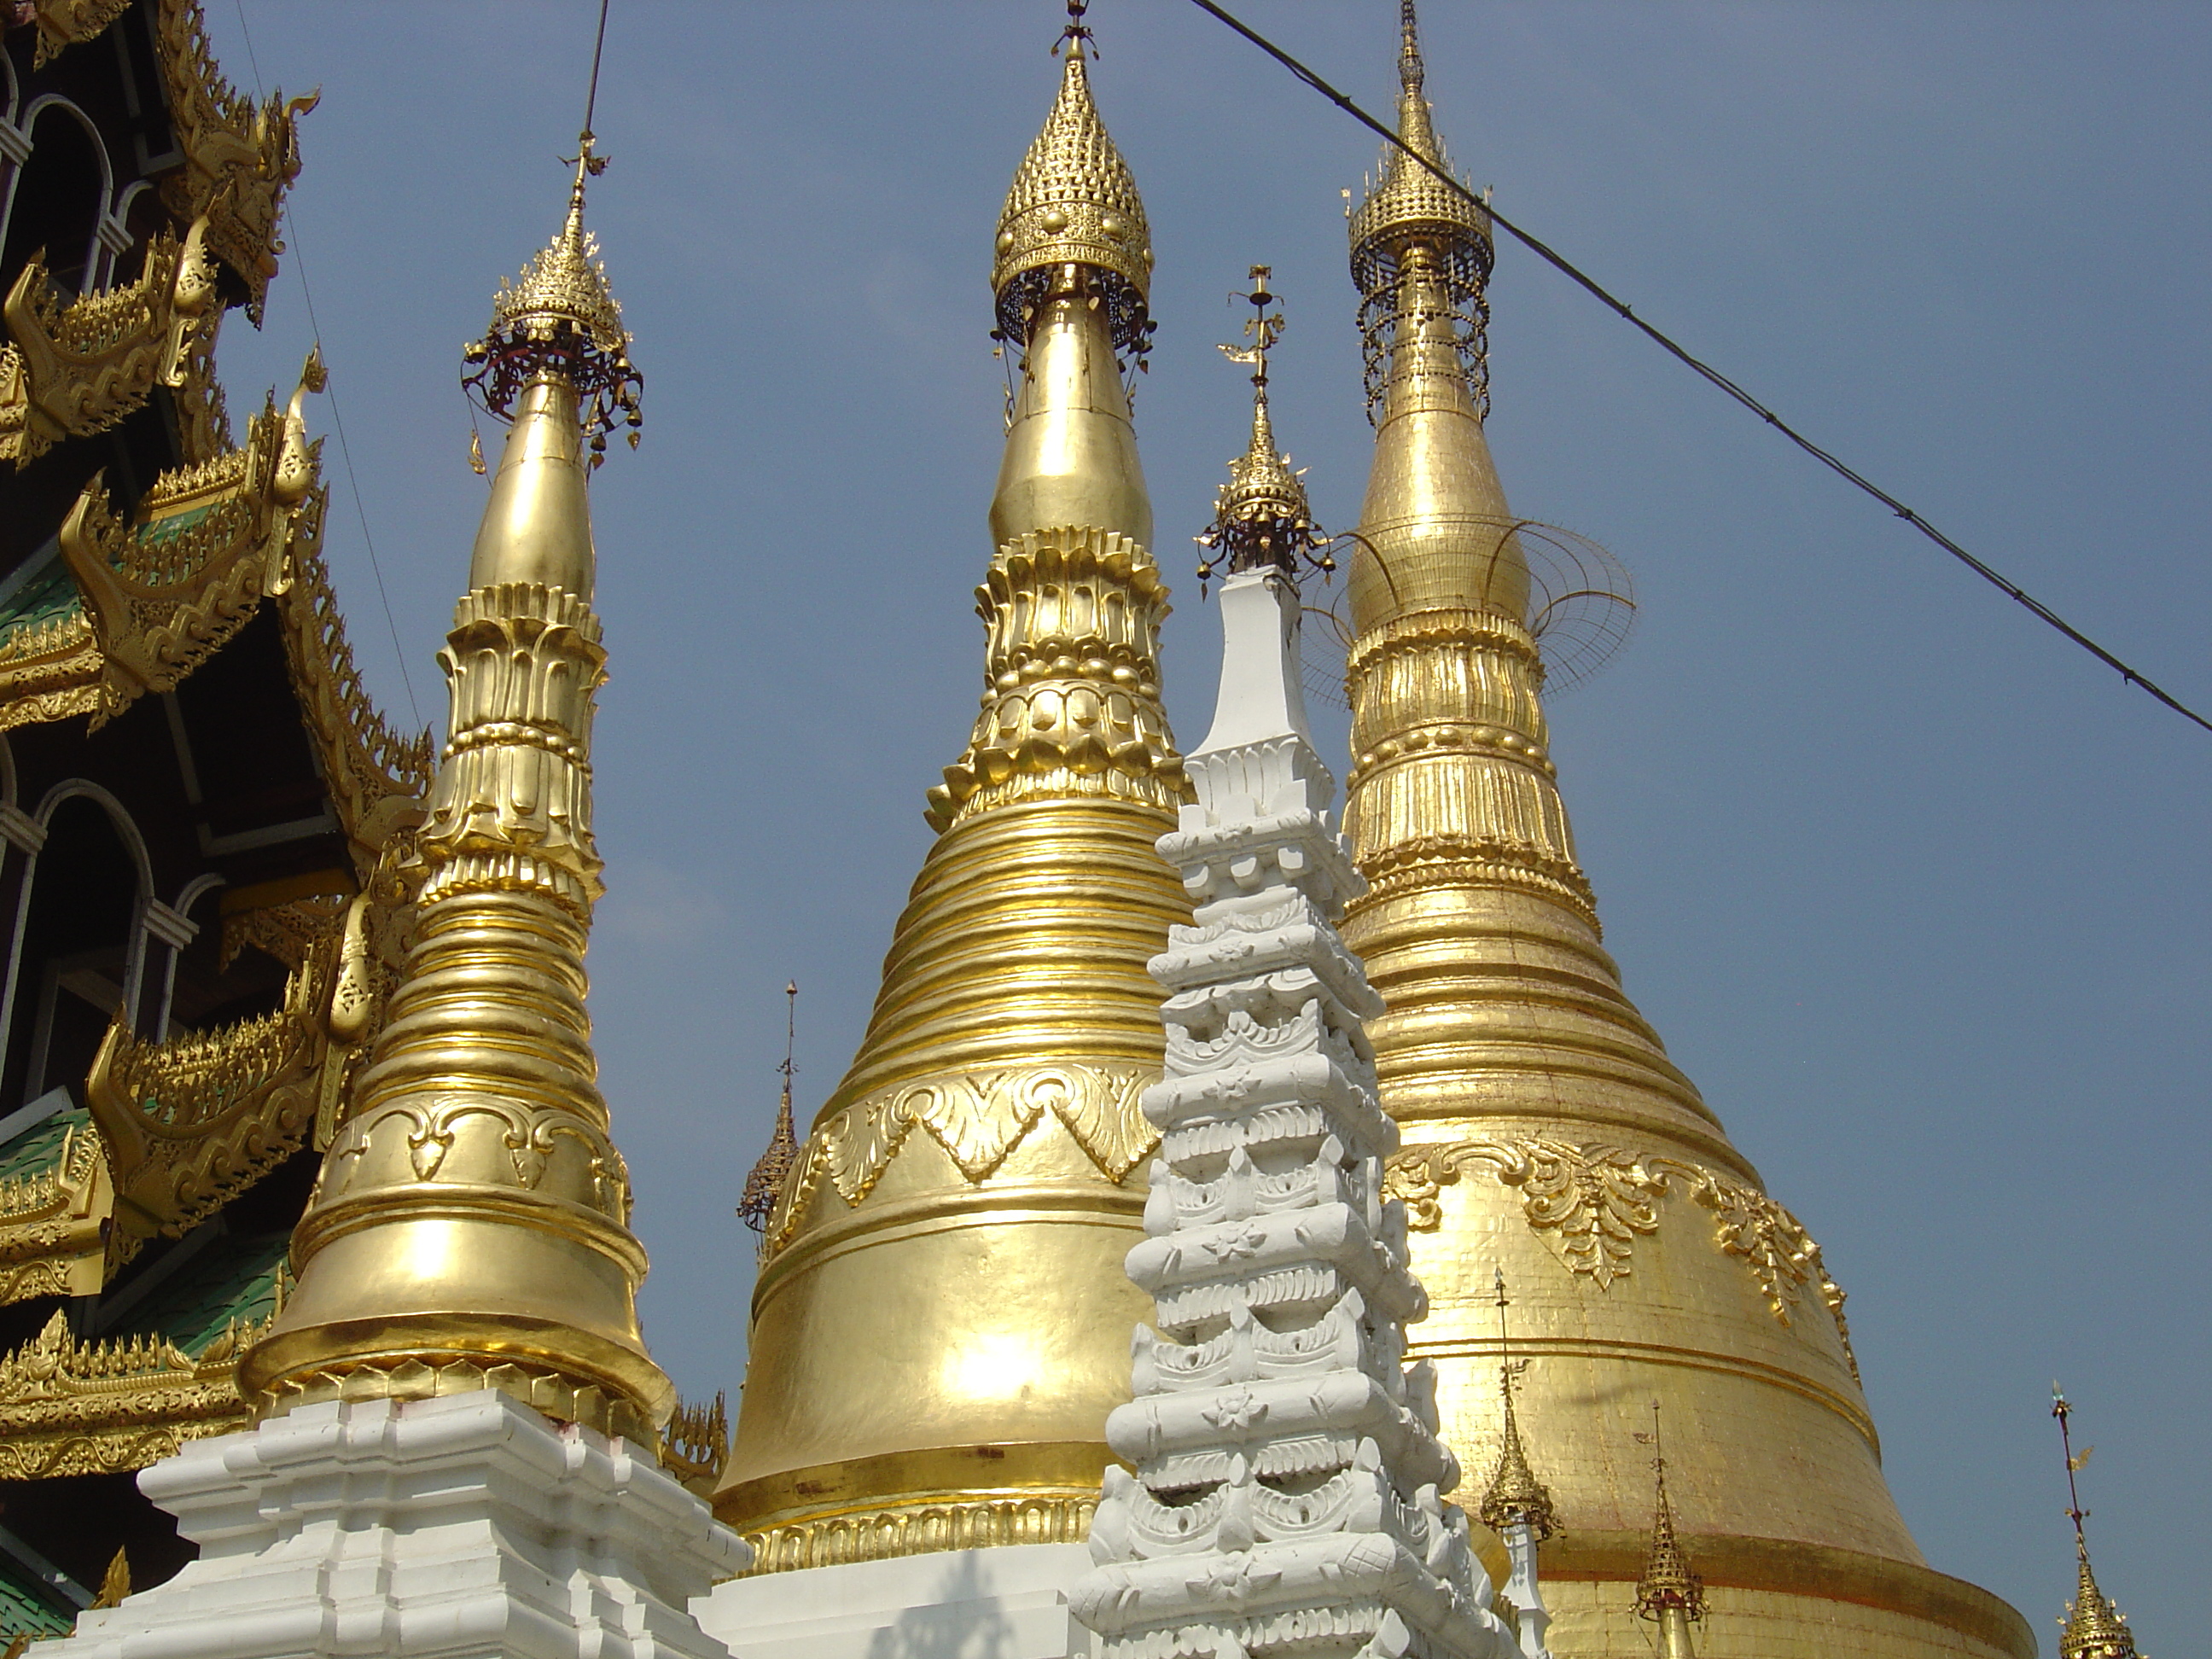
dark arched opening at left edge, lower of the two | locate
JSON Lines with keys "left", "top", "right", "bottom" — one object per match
{"left": 0, "top": 785, "right": 150, "bottom": 1106}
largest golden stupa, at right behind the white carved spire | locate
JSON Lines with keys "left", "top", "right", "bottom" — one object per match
{"left": 1345, "top": 0, "right": 2035, "bottom": 1659}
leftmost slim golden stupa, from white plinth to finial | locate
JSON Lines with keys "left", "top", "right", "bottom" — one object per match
{"left": 239, "top": 128, "right": 675, "bottom": 1445}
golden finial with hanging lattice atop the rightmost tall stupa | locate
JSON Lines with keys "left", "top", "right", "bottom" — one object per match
{"left": 1352, "top": 0, "right": 1495, "bottom": 420}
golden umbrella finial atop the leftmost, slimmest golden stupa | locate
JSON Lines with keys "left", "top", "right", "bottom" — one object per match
{"left": 460, "top": 126, "right": 646, "bottom": 467}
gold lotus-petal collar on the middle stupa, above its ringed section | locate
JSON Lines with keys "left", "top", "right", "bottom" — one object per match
{"left": 924, "top": 528, "right": 1190, "bottom": 832}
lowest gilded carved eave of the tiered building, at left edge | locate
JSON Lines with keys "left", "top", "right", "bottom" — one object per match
{"left": 0, "top": 1314, "right": 268, "bottom": 1480}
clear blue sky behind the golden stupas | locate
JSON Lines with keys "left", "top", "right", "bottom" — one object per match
{"left": 208, "top": 0, "right": 2212, "bottom": 1652}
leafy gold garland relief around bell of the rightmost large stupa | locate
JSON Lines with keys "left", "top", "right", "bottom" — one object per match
{"left": 1385, "top": 1135, "right": 1858, "bottom": 1378}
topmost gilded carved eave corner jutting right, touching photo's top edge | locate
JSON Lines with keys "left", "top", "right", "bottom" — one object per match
{"left": 154, "top": 0, "right": 317, "bottom": 328}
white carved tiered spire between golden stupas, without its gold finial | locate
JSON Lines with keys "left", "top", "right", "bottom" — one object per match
{"left": 1071, "top": 568, "right": 1520, "bottom": 1659}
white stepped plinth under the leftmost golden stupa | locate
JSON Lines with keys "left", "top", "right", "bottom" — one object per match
{"left": 54, "top": 1391, "right": 750, "bottom": 1659}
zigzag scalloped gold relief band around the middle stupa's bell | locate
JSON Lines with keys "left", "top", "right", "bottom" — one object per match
{"left": 761, "top": 1066, "right": 1159, "bottom": 1254}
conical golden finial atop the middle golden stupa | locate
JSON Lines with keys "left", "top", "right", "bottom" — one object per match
{"left": 991, "top": 0, "right": 1152, "bottom": 363}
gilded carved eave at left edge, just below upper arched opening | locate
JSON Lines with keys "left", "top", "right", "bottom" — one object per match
{"left": 0, "top": 224, "right": 219, "bottom": 467}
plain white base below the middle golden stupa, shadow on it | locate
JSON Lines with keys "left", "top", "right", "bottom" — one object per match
{"left": 692, "top": 1544, "right": 1091, "bottom": 1659}
